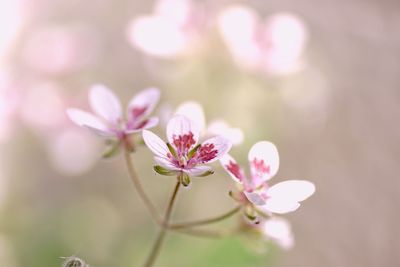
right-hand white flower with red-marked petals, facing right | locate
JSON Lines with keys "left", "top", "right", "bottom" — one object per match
{"left": 220, "top": 141, "right": 315, "bottom": 220}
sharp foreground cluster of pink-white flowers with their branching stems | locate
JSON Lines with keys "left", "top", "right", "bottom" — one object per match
{"left": 67, "top": 85, "right": 315, "bottom": 266}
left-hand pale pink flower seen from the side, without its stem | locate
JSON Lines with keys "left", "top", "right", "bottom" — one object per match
{"left": 67, "top": 85, "right": 160, "bottom": 140}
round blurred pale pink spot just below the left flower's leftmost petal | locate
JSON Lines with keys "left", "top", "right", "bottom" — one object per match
{"left": 48, "top": 128, "right": 100, "bottom": 176}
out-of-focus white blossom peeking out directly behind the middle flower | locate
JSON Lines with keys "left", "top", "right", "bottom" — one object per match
{"left": 175, "top": 101, "right": 243, "bottom": 145}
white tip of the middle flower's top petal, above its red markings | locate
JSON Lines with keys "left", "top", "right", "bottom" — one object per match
{"left": 167, "top": 115, "right": 199, "bottom": 146}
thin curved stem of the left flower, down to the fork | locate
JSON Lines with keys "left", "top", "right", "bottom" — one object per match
{"left": 124, "top": 149, "right": 161, "bottom": 224}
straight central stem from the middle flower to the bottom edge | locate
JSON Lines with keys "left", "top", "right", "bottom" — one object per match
{"left": 143, "top": 181, "right": 181, "bottom": 267}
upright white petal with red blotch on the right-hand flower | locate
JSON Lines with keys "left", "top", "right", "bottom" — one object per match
{"left": 248, "top": 141, "right": 279, "bottom": 185}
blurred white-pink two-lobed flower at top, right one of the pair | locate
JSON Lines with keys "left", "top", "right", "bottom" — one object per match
{"left": 218, "top": 5, "right": 308, "bottom": 74}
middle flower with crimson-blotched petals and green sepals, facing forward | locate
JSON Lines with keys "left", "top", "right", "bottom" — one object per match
{"left": 143, "top": 115, "right": 232, "bottom": 186}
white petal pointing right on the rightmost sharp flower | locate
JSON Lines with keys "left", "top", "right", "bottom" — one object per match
{"left": 268, "top": 180, "right": 315, "bottom": 202}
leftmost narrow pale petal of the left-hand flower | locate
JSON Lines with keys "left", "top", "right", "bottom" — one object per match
{"left": 67, "top": 108, "right": 115, "bottom": 137}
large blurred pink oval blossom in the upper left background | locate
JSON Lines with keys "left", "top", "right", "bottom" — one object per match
{"left": 22, "top": 26, "right": 99, "bottom": 74}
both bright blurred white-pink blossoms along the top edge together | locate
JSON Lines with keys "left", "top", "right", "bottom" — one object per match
{"left": 127, "top": 0, "right": 308, "bottom": 74}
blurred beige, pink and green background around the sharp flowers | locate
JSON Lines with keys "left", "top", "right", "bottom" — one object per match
{"left": 0, "top": 0, "right": 400, "bottom": 267}
